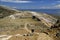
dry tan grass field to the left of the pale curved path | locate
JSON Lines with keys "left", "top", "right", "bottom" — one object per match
{"left": 0, "top": 17, "right": 39, "bottom": 34}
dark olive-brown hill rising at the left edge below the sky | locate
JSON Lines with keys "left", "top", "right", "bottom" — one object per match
{"left": 0, "top": 6, "right": 15, "bottom": 18}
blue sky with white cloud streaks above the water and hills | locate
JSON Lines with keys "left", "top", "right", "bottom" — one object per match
{"left": 0, "top": 0, "right": 60, "bottom": 9}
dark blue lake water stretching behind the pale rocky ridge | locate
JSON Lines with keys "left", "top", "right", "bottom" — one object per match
{"left": 18, "top": 9, "right": 60, "bottom": 16}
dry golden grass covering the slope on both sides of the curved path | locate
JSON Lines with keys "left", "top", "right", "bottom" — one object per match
{"left": 0, "top": 10, "right": 60, "bottom": 40}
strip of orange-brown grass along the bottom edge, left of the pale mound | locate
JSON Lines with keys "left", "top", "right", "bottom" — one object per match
{"left": 9, "top": 34, "right": 38, "bottom": 40}
